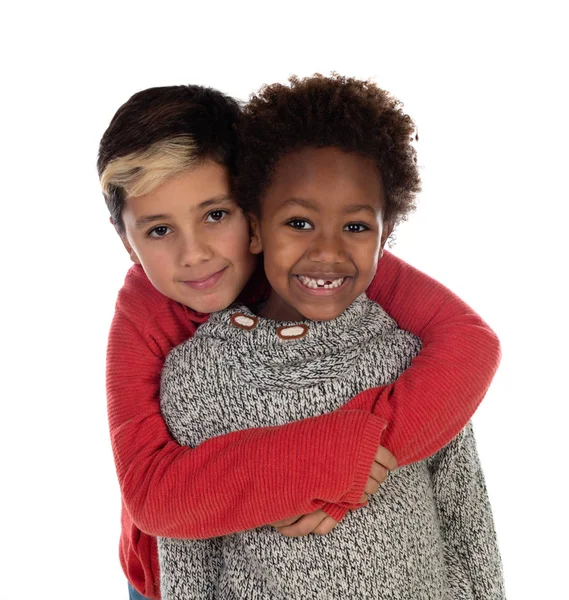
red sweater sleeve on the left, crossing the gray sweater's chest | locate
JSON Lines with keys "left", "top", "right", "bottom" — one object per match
{"left": 107, "top": 311, "right": 386, "bottom": 538}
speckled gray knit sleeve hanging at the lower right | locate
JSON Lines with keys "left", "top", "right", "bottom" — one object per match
{"left": 427, "top": 424, "right": 506, "bottom": 600}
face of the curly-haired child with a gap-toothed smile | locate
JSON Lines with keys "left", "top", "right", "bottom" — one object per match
{"left": 251, "top": 148, "right": 392, "bottom": 321}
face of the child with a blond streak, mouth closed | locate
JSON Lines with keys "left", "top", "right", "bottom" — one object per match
{"left": 122, "top": 161, "right": 255, "bottom": 313}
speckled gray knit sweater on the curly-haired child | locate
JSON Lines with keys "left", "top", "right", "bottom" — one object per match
{"left": 158, "top": 296, "right": 504, "bottom": 600}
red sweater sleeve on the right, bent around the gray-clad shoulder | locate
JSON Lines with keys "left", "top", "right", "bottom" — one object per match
{"left": 345, "top": 252, "right": 500, "bottom": 466}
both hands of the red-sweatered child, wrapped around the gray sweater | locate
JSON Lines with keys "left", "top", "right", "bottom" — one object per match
{"left": 271, "top": 446, "right": 397, "bottom": 537}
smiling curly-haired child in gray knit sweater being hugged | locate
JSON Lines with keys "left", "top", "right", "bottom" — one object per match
{"left": 159, "top": 76, "right": 504, "bottom": 600}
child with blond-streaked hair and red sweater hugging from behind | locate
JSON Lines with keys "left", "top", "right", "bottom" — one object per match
{"left": 98, "top": 86, "right": 499, "bottom": 598}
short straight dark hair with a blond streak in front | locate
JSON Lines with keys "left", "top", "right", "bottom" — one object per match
{"left": 97, "top": 85, "right": 241, "bottom": 233}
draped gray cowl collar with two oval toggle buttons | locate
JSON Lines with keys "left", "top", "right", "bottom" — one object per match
{"left": 195, "top": 294, "right": 396, "bottom": 388}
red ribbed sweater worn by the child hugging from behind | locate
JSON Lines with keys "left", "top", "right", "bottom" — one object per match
{"left": 107, "top": 252, "right": 500, "bottom": 598}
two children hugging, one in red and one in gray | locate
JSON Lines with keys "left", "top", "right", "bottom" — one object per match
{"left": 98, "top": 75, "right": 505, "bottom": 600}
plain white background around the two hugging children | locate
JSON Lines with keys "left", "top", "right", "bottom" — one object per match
{"left": 0, "top": 0, "right": 569, "bottom": 600}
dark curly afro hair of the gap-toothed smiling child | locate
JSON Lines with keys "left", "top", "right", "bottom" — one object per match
{"left": 235, "top": 74, "right": 421, "bottom": 226}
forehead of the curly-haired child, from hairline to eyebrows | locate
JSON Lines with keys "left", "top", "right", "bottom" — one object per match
{"left": 266, "top": 148, "right": 383, "bottom": 206}
